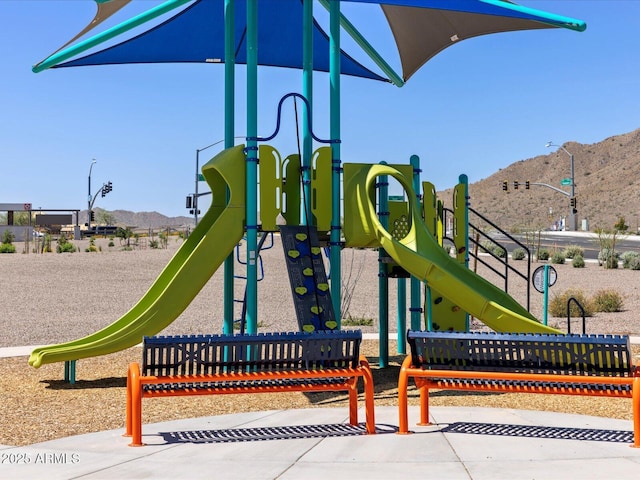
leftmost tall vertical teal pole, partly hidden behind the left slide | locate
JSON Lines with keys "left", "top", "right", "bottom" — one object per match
{"left": 222, "top": 0, "right": 236, "bottom": 334}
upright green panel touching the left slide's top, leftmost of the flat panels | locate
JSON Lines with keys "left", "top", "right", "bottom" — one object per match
{"left": 258, "top": 145, "right": 282, "bottom": 232}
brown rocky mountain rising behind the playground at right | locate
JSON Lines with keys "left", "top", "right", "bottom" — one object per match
{"left": 438, "top": 129, "right": 640, "bottom": 232}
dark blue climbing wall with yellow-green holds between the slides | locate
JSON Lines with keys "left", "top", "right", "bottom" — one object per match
{"left": 280, "top": 225, "right": 338, "bottom": 332}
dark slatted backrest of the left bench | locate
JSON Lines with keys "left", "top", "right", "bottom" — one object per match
{"left": 142, "top": 330, "right": 362, "bottom": 376}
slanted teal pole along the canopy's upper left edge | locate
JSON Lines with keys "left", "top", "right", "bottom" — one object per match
{"left": 31, "top": 0, "right": 191, "bottom": 73}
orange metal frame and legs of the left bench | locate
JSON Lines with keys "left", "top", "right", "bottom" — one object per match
{"left": 125, "top": 356, "right": 376, "bottom": 447}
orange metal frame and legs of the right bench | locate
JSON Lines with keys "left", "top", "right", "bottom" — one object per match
{"left": 398, "top": 355, "right": 640, "bottom": 448}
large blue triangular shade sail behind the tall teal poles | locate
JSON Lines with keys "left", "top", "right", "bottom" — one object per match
{"left": 57, "top": 0, "right": 387, "bottom": 81}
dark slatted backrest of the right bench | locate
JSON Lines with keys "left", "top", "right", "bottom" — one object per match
{"left": 407, "top": 331, "right": 632, "bottom": 377}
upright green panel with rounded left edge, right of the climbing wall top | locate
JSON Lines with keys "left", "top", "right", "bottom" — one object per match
{"left": 311, "top": 147, "right": 333, "bottom": 233}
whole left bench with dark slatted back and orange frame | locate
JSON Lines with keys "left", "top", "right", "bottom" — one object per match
{"left": 125, "top": 331, "right": 375, "bottom": 446}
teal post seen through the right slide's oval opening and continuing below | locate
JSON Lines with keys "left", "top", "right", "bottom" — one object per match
{"left": 378, "top": 167, "right": 389, "bottom": 368}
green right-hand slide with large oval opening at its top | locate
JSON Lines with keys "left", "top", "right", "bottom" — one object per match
{"left": 345, "top": 164, "right": 562, "bottom": 333}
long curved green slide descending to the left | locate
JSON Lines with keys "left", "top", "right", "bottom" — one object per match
{"left": 29, "top": 145, "right": 245, "bottom": 368}
